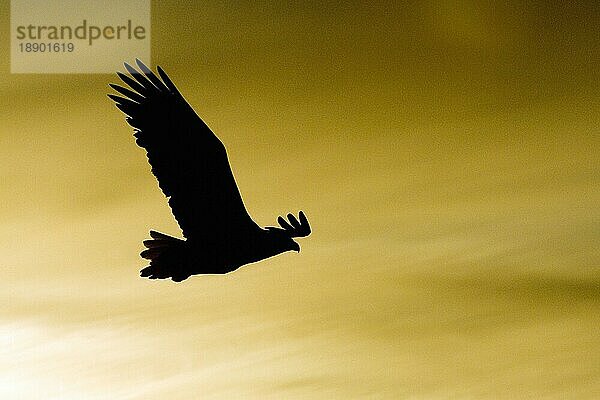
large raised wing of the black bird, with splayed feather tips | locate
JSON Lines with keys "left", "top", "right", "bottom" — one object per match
{"left": 108, "top": 60, "right": 260, "bottom": 241}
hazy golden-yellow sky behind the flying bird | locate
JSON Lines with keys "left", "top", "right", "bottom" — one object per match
{"left": 0, "top": 0, "right": 600, "bottom": 400}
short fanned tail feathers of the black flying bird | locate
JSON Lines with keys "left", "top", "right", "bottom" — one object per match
{"left": 140, "top": 231, "right": 189, "bottom": 282}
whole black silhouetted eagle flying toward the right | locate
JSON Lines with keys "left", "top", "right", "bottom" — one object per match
{"left": 108, "top": 59, "right": 310, "bottom": 282}
